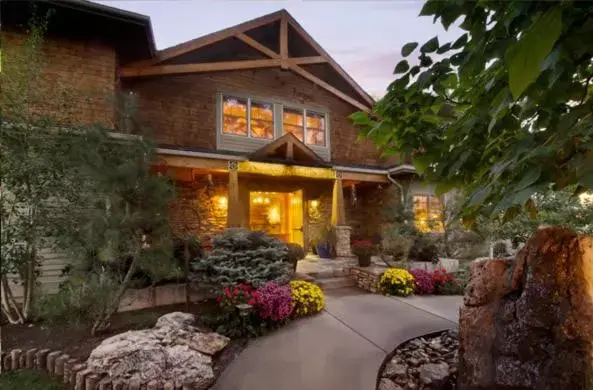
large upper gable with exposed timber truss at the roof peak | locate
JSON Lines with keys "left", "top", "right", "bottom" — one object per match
{"left": 120, "top": 9, "right": 374, "bottom": 111}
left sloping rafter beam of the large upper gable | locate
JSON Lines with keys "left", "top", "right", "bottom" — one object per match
{"left": 153, "top": 10, "right": 286, "bottom": 64}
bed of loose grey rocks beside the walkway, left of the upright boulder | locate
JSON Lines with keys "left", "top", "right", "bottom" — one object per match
{"left": 377, "top": 329, "right": 459, "bottom": 390}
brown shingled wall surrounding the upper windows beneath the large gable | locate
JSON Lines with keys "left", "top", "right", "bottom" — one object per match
{"left": 122, "top": 68, "right": 396, "bottom": 166}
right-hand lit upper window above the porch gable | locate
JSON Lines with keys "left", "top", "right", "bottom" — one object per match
{"left": 282, "top": 107, "right": 326, "bottom": 146}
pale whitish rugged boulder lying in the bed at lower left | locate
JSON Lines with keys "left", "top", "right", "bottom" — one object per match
{"left": 87, "top": 313, "right": 230, "bottom": 390}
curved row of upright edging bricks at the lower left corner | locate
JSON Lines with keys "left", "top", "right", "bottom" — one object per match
{"left": 0, "top": 348, "right": 177, "bottom": 390}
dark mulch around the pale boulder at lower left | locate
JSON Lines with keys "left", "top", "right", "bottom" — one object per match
{"left": 2, "top": 302, "right": 247, "bottom": 376}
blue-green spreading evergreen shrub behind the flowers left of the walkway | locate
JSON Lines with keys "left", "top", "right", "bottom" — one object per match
{"left": 193, "top": 229, "right": 292, "bottom": 287}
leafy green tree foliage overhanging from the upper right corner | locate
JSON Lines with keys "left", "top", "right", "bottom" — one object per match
{"left": 352, "top": 0, "right": 593, "bottom": 220}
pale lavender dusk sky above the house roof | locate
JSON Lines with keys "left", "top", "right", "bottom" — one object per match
{"left": 97, "top": 0, "right": 460, "bottom": 96}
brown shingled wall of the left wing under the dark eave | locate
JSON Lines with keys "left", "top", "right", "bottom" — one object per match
{"left": 1, "top": 31, "right": 117, "bottom": 126}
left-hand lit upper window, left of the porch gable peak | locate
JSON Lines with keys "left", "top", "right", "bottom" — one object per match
{"left": 222, "top": 95, "right": 274, "bottom": 139}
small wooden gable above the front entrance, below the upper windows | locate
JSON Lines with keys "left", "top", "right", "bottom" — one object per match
{"left": 249, "top": 133, "right": 325, "bottom": 164}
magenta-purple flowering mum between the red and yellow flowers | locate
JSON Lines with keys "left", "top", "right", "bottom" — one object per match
{"left": 256, "top": 282, "right": 292, "bottom": 322}
